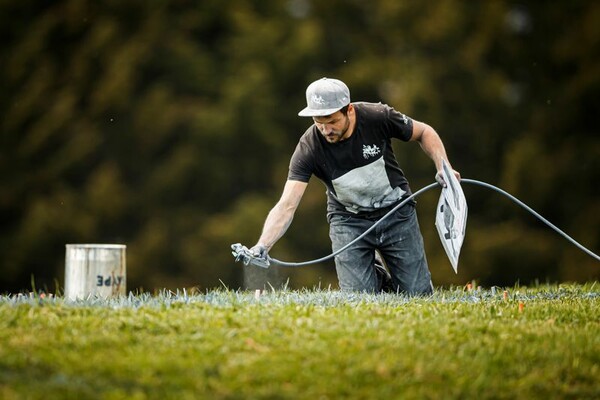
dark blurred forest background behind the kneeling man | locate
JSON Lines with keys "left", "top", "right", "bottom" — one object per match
{"left": 0, "top": 0, "right": 600, "bottom": 293}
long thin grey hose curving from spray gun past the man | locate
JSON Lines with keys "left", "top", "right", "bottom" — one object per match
{"left": 267, "top": 179, "right": 600, "bottom": 267}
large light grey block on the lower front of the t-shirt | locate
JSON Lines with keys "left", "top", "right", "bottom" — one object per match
{"left": 331, "top": 157, "right": 406, "bottom": 213}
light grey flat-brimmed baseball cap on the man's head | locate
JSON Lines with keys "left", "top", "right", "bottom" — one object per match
{"left": 298, "top": 78, "right": 350, "bottom": 117}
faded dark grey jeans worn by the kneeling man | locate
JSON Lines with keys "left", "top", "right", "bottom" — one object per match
{"left": 329, "top": 204, "right": 433, "bottom": 295}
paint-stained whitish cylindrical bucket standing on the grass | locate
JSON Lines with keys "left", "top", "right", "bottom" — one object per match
{"left": 65, "top": 244, "right": 126, "bottom": 300}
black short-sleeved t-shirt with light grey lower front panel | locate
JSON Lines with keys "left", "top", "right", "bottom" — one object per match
{"left": 288, "top": 102, "right": 413, "bottom": 215}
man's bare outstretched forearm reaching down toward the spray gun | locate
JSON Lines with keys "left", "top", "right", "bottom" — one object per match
{"left": 252, "top": 180, "right": 308, "bottom": 255}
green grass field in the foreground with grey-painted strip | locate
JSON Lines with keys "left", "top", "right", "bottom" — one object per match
{"left": 0, "top": 284, "right": 600, "bottom": 399}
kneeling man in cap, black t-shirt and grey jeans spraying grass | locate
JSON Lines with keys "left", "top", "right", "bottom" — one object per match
{"left": 250, "top": 78, "right": 460, "bottom": 295}
